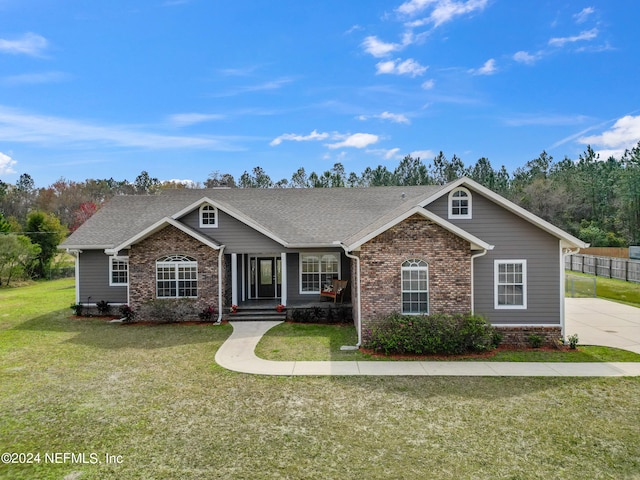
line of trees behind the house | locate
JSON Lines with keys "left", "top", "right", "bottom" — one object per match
{"left": 0, "top": 142, "right": 640, "bottom": 283}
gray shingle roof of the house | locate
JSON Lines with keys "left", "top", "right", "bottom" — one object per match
{"left": 61, "top": 185, "right": 445, "bottom": 249}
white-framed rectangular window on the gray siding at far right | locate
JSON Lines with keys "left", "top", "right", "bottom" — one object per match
{"left": 494, "top": 260, "right": 527, "bottom": 309}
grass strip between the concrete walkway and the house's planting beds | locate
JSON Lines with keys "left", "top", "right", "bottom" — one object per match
{"left": 256, "top": 323, "right": 640, "bottom": 362}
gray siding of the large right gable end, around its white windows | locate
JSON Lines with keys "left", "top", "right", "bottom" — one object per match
{"left": 426, "top": 191, "right": 562, "bottom": 325}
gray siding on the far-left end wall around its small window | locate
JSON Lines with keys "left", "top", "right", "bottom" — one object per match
{"left": 78, "top": 250, "right": 127, "bottom": 304}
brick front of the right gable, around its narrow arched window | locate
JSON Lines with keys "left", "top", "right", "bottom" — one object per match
{"left": 359, "top": 215, "right": 471, "bottom": 329}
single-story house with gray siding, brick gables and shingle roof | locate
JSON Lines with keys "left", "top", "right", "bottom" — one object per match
{"left": 60, "top": 178, "right": 587, "bottom": 339}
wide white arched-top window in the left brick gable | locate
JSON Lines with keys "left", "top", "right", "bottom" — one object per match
{"left": 156, "top": 255, "right": 198, "bottom": 298}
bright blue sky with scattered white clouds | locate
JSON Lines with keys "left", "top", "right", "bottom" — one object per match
{"left": 0, "top": 0, "right": 640, "bottom": 186}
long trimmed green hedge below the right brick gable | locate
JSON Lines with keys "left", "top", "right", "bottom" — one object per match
{"left": 363, "top": 313, "right": 502, "bottom": 355}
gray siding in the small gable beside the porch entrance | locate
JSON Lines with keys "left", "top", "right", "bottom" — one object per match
{"left": 180, "top": 208, "right": 287, "bottom": 253}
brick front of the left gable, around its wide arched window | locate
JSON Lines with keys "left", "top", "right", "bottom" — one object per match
{"left": 129, "top": 225, "right": 224, "bottom": 316}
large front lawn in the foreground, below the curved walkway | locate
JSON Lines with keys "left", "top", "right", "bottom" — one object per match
{"left": 0, "top": 280, "right": 640, "bottom": 480}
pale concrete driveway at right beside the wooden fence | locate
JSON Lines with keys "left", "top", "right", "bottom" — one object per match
{"left": 565, "top": 298, "right": 640, "bottom": 353}
